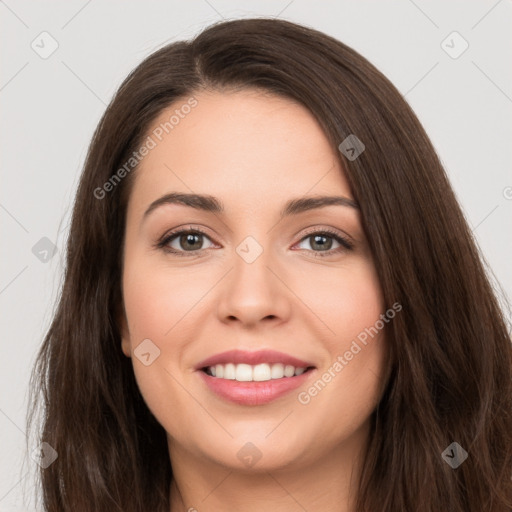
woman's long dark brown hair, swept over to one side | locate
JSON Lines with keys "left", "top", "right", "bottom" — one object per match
{"left": 27, "top": 19, "right": 512, "bottom": 512}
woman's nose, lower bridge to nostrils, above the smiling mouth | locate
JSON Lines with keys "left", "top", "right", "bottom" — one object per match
{"left": 217, "top": 247, "right": 293, "bottom": 327}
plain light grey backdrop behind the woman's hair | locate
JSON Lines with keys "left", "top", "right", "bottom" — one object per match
{"left": 0, "top": 0, "right": 512, "bottom": 512}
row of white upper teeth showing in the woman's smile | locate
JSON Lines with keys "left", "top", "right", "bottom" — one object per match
{"left": 206, "top": 363, "right": 306, "bottom": 382}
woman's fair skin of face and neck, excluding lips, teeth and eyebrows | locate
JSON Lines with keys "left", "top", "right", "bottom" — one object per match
{"left": 121, "top": 90, "right": 387, "bottom": 512}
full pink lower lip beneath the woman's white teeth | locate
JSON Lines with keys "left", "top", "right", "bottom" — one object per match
{"left": 199, "top": 368, "right": 315, "bottom": 405}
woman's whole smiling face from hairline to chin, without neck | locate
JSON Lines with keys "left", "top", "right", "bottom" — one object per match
{"left": 121, "top": 90, "right": 387, "bottom": 469}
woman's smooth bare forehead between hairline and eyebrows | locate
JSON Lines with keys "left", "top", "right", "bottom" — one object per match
{"left": 130, "top": 90, "right": 351, "bottom": 215}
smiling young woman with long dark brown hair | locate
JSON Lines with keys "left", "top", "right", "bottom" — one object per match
{"left": 29, "top": 19, "right": 512, "bottom": 512}
